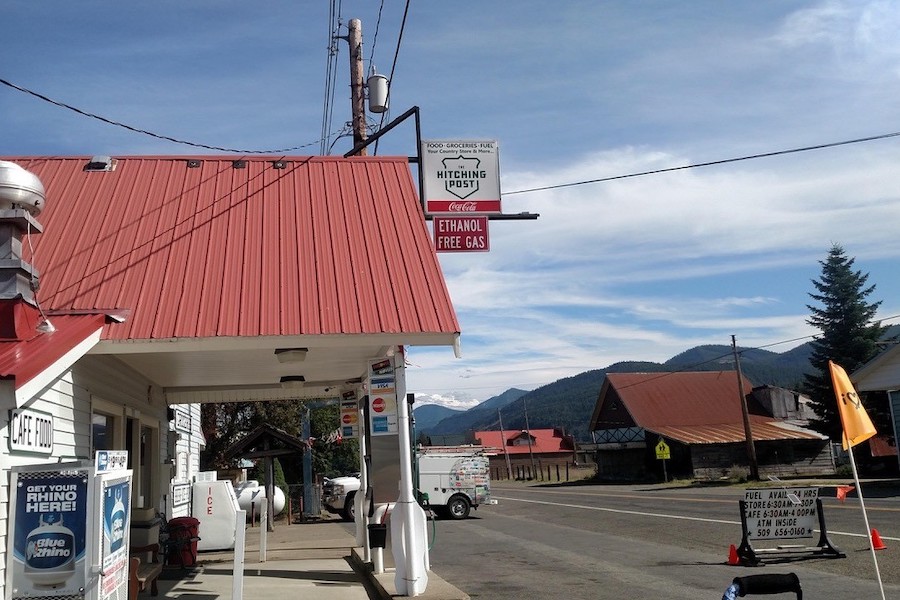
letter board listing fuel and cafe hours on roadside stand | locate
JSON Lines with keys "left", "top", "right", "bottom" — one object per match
{"left": 744, "top": 487, "right": 819, "bottom": 540}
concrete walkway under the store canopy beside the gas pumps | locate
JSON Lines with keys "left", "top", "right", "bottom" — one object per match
{"left": 150, "top": 519, "right": 469, "bottom": 600}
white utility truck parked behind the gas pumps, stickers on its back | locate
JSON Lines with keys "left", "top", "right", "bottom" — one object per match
{"left": 322, "top": 446, "right": 497, "bottom": 521}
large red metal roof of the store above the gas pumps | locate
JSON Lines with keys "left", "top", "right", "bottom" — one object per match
{"left": 3, "top": 156, "right": 459, "bottom": 340}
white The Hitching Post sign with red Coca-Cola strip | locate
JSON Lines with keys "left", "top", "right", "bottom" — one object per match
{"left": 419, "top": 140, "right": 500, "bottom": 215}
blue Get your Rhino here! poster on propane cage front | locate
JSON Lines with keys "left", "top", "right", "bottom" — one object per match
{"left": 6, "top": 465, "right": 91, "bottom": 600}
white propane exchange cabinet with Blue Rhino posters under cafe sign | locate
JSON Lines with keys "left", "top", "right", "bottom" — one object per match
{"left": 5, "top": 451, "right": 131, "bottom": 600}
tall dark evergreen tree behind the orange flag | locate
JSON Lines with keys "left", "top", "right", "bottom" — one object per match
{"left": 804, "top": 244, "right": 889, "bottom": 441}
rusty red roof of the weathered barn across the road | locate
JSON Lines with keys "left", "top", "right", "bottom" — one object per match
{"left": 591, "top": 371, "right": 821, "bottom": 444}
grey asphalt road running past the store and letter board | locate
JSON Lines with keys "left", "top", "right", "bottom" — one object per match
{"left": 431, "top": 482, "right": 900, "bottom": 600}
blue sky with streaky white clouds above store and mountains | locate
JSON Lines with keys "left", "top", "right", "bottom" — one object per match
{"left": 0, "top": 0, "right": 900, "bottom": 407}
